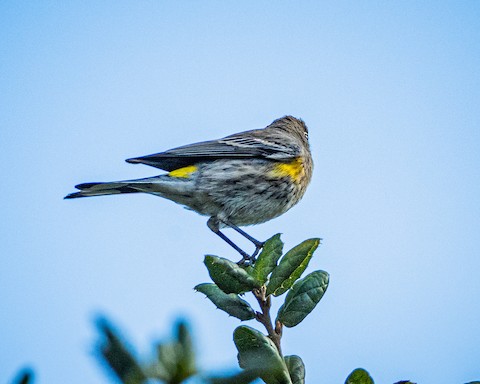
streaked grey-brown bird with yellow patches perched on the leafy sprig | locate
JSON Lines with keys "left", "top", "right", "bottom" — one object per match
{"left": 65, "top": 116, "right": 313, "bottom": 263}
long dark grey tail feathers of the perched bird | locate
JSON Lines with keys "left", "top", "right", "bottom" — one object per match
{"left": 65, "top": 178, "right": 158, "bottom": 199}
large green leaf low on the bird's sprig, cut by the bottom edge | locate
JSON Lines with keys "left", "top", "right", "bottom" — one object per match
{"left": 233, "top": 326, "right": 292, "bottom": 384}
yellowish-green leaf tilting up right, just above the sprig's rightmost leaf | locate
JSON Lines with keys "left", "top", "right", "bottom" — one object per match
{"left": 267, "top": 239, "right": 320, "bottom": 296}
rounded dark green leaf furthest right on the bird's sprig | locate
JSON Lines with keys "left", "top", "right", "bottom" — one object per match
{"left": 277, "top": 271, "right": 329, "bottom": 327}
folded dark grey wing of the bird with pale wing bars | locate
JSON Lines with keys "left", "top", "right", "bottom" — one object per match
{"left": 126, "top": 129, "right": 298, "bottom": 172}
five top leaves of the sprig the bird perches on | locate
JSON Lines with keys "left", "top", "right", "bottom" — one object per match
{"left": 195, "top": 234, "right": 329, "bottom": 327}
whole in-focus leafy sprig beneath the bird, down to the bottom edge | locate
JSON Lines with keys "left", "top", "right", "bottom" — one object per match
{"left": 195, "top": 234, "right": 329, "bottom": 384}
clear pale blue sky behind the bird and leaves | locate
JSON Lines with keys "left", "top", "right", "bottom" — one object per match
{"left": 0, "top": 1, "right": 480, "bottom": 384}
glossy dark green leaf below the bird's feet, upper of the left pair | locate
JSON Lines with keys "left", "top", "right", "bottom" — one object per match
{"left": 204, "top": 255, "right": 260, "bottom": 293}
